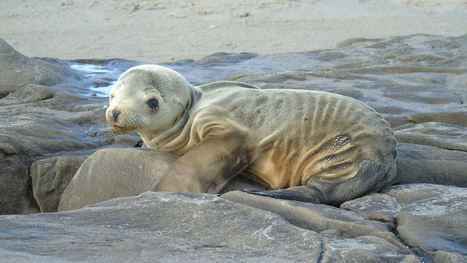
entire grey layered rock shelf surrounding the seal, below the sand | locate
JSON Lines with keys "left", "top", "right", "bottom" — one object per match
{"left": 0, "top": 35, "right": 467, "bottom": 262}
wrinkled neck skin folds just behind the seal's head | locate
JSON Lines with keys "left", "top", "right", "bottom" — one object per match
{"left": 138, "top": 85, "right": 201, "bottom": 149}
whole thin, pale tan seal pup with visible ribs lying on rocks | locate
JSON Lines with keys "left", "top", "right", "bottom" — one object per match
{"left": 106, "top": 65, "right": 397, "bottom": 205}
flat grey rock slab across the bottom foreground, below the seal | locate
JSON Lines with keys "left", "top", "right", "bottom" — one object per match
{"left": 0, "top": 184, "right": 467, "bottom": 262}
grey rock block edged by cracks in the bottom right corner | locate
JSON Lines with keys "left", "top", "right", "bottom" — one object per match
{"left": 384, "top": 184, "right": 467, "bottom": 255}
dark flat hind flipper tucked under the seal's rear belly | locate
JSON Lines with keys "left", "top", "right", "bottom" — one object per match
{"left": 242, "top": 185, "right": 329, "bottom": 204}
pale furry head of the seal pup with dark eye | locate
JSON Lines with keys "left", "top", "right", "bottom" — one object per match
{"left": 105, "top": 65, "right": 192, "bottom": 134}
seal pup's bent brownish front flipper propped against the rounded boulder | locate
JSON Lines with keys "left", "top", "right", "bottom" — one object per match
{"left": 152, "top": 117, "right": 255, "bottom": 194}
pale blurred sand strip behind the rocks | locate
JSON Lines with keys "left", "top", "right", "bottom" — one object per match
{"left": 0, "top": 0, "right": 467, "bottom": 62}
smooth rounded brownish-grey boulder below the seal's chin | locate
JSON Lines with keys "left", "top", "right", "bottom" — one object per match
{"left": 58, "top": 148, "right": 264, "bottom": 211}
